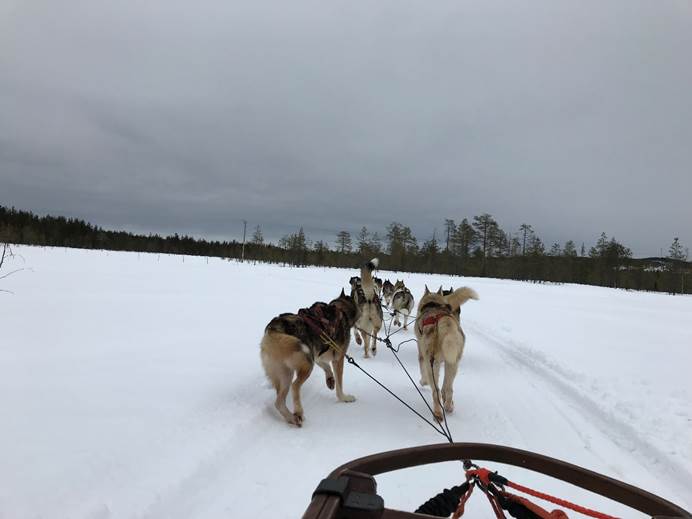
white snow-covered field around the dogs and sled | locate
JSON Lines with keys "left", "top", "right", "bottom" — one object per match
{"left": 0, "top": 247, "right": 692, "bottom": 519}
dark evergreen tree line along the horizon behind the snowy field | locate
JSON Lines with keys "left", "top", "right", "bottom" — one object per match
{"left": 0, "top": 206, "right": 692, "bottom": 293}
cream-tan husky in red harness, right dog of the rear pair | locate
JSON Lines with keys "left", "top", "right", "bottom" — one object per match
{"left": 415, "top": 286, "right": 478, "bottom": 421}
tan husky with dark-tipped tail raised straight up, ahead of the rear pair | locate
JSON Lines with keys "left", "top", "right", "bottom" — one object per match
{"left": 351, "top": 258, "right": 383, "bottom": 359}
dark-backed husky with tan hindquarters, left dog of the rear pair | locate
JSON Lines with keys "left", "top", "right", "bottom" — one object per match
{"left": 260, "top": 289, "right": 360, "bottom": 427}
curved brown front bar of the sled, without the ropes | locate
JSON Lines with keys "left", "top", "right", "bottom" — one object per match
{"left": 303, "top": 443, "right": 692, "bottom": 519}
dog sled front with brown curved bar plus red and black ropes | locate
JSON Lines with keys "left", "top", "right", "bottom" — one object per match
{"left": 303, "top": 443, "right": 692, "bottom": 519}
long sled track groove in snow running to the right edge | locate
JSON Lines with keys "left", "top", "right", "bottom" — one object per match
{"left": 465, "top": 320, "right": 692, "bottom": 508}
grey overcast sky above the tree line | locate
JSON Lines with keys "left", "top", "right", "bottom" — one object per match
{"left": 0, "top": 0, "right": 692, "bottom": 256}
